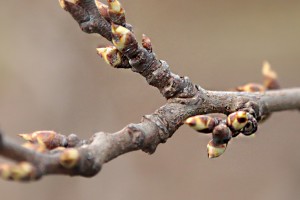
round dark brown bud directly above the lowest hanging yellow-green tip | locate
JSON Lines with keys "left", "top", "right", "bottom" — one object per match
{"left": 212, "top": 124, "right": 232, "bottom": 145}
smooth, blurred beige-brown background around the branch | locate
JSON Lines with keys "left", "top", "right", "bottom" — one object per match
{"left": 0, "top": 0, "right": 300, "bottom": 200}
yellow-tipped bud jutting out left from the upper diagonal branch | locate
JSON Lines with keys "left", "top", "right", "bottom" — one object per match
{"left": 97, "top": 46, "right": 122, "bottom": 67}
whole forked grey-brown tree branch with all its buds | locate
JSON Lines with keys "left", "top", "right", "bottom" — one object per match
{"left": 0, "top": 0, "right": 300, "bottom": 181}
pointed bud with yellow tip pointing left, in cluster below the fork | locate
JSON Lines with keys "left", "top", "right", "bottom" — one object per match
{"left": 184, "top": 115, "right": 216, "bottom": 133}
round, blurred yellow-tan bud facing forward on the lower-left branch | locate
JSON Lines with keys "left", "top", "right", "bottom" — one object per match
{"left": 59, "top": 148, "right": 79, "bottom": 169}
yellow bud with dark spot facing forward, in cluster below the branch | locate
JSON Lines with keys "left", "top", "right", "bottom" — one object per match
{"left": 227, "top": 111, "right": 248, "bottom": 131}
